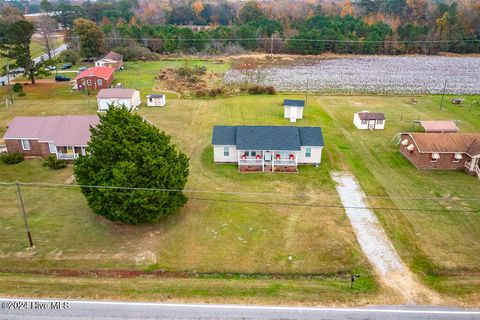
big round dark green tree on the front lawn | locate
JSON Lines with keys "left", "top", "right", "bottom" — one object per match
{"left": 74, "top": 108, "right": 188, "bottom": 224}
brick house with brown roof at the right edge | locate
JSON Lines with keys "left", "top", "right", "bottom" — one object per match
{"left": 400, "top": 132, "right": 480, "bottom": 178}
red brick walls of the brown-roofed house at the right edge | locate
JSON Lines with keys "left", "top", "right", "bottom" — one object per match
{"left": 400, "top": 134, "right": 471, "bottom": 170}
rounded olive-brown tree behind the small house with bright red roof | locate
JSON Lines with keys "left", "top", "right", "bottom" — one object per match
{"left": 73, "top": 18, "right": 105, "bottom": 60}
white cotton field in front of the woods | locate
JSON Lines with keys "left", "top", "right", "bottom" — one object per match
{"left": 224, "top": 56, "right": 480, "bottom": 94}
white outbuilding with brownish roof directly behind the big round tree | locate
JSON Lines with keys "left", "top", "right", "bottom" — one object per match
{"left": 97, "top": 88, "right": 142, "bottom": 111}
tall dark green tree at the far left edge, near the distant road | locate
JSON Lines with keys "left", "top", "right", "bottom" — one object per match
{"left": 0, "top": 20, "right": 42, "bottom": 84}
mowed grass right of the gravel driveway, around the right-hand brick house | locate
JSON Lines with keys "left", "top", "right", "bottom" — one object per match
{"left": 316, "top": 96, "right": 480, "bottom": 299}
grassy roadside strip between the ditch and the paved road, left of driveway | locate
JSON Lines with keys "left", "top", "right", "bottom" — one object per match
{"left": 0, "top": 273, "right": 382, "bottom": 306}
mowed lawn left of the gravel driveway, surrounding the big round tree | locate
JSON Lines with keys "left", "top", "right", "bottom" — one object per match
{"left": 0, "top": 87, "right": 370, "bottom": 282}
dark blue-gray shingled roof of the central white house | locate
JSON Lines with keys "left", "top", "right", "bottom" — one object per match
{"left": 212, "top": 126, "right": 324, "bottom": 150}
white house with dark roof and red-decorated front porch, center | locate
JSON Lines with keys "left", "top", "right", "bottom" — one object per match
{"left": 212, "top": 126, "right": 324, "bottom": 172}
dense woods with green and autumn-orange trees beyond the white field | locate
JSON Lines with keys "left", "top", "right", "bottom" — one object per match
{"left": 0, "top": 0, "right": 480, "bottom": 60}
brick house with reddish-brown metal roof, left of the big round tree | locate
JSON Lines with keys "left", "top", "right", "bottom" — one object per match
{"left": 3, "top": 115, "right": 99, "bottom": 160}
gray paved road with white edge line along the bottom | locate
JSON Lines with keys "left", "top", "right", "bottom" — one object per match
{"left": 0, "top": 298, "right": 480, "bottom": 320}
